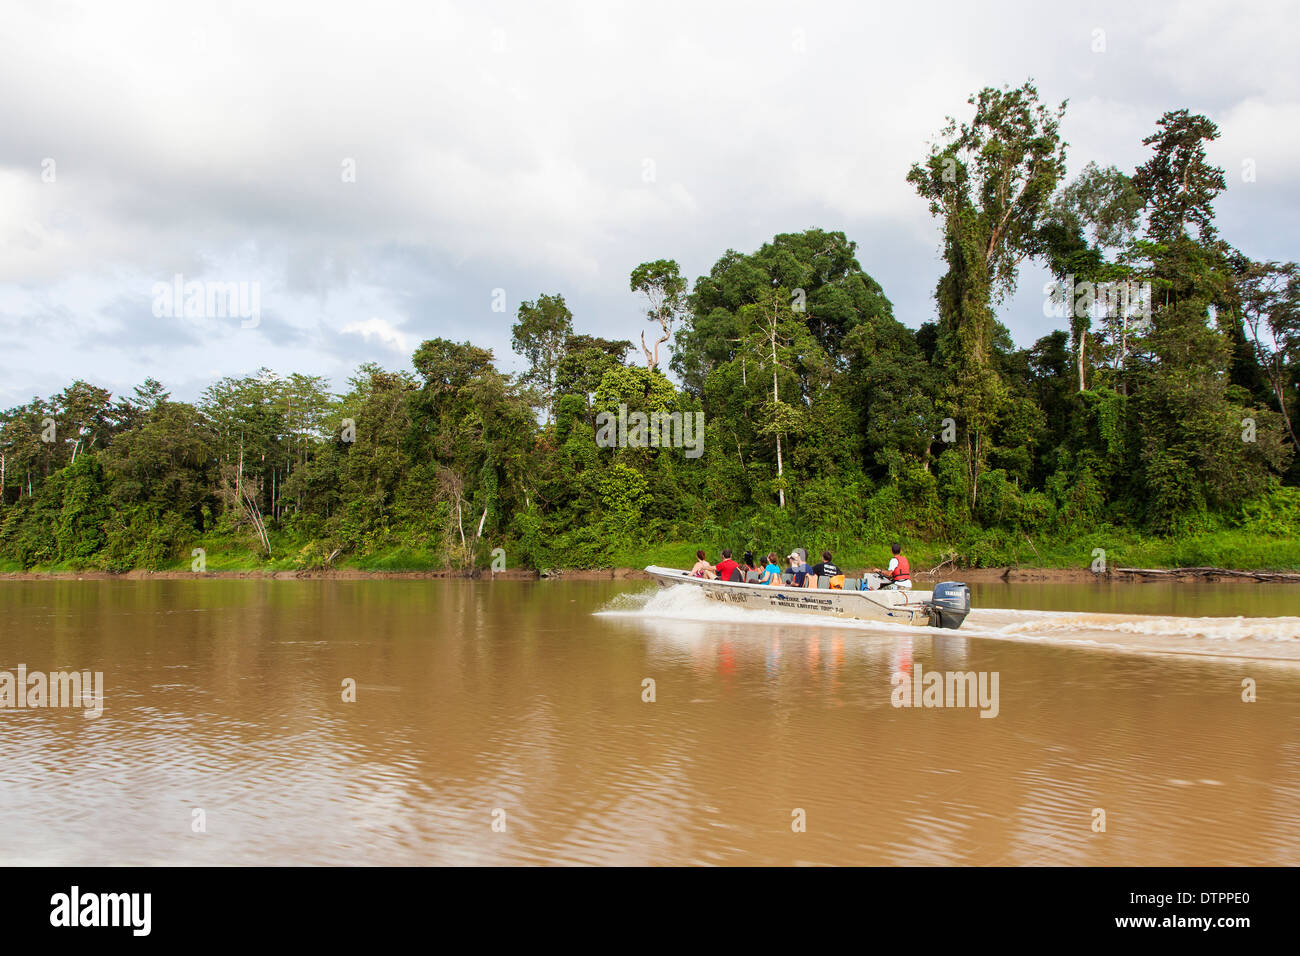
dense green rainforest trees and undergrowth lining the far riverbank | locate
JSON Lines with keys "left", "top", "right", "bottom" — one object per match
{"left": 0, "top": 85, "right": 1300, "bottom": 571}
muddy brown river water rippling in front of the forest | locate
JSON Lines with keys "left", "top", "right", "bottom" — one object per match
{"left": 0, "top": 579, "right": 1300, "bottom": 865}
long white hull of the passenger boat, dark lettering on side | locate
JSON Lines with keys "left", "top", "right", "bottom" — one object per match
{"left": 646, "top": 564, "right": 965, "bottom": 627}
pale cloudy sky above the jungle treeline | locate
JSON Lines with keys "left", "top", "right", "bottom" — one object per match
{"left": 0, "top": 0, "right": 1300, "bottom": 408}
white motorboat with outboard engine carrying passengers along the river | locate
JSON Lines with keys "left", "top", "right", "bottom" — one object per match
{"left": 645, "top": 564, "right": 971, "bottom": 628}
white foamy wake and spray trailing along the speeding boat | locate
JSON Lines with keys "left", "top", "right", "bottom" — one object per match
{"left": 597, "top": 585, "right": 1300, "bottom": 663}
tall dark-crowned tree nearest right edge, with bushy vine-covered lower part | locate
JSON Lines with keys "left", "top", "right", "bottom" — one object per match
{"left": 1131, "top": 109, "right": 1287, "bottom": 533}
